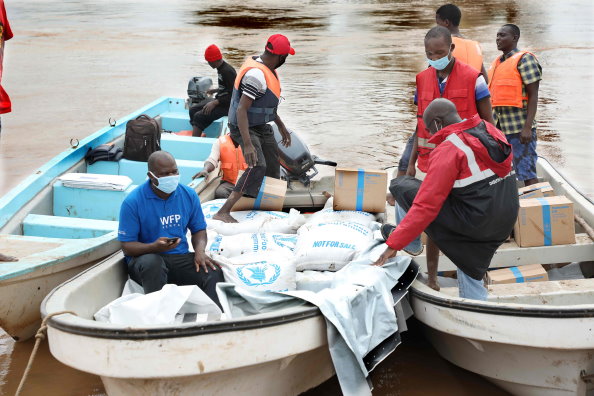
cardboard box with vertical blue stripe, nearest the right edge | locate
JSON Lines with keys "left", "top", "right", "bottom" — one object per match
{"left": 514, "top": 196, "right": 575, "bottom": 247}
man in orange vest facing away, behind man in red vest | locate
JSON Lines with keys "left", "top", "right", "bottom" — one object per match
{"left": 435, "top": 4, "right": 488, "bottom": 82}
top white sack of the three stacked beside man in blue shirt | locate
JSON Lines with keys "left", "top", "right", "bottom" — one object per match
{"left": 202, "top": 199, "right": 305, "bottom": 235}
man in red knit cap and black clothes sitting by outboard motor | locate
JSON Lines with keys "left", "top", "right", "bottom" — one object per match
{"left": 190, "top": 44, "right": 237, "bottom": 136}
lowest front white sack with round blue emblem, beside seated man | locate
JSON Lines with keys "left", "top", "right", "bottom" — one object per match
{"left": 213, "top": 252, "right": 296, "bottom": 291}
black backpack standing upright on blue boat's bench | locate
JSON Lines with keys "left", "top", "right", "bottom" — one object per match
{"left": 124, "top": 114, "right": 161, "bottom": 161}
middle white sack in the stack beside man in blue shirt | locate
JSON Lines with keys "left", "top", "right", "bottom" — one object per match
{"left": 206, "top": 232, "right": 297, "bottom": 258}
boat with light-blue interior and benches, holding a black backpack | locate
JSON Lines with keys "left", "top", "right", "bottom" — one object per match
{"left": 0, "top": 98, "right": 227, "bottom": 341}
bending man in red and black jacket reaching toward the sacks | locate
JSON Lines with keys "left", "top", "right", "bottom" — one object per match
{"left": 375, "top": 99, "right": 519, "bottom": 300}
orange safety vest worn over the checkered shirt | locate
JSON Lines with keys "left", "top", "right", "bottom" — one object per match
{"left": 488, "top": 51, "right": 534, "bottom": 108}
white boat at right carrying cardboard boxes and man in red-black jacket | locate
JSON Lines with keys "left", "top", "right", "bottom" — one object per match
{"left": 410, "top": 158, "right": 594, "bottom": 396}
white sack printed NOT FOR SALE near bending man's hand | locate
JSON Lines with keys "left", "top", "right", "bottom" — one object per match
{"left": 294, "top": 200, "right": 378, "bottom": 271}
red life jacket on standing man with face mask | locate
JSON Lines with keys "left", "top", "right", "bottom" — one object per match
{"left": 417, "top": 60, "right": 480, "bottom": 172}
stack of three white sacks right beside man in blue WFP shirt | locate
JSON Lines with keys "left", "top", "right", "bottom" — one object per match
{"left": 202, "top": 199, "right": 296, "bottom": 291}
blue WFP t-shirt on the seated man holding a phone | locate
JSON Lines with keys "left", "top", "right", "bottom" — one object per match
{"left": 118, "top": 180, "right": 206, "bottom": 254}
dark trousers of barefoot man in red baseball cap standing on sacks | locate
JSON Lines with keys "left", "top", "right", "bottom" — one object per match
{"left": 229, "top": 124, "right": 280, "bottom": 198}
